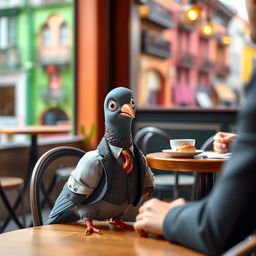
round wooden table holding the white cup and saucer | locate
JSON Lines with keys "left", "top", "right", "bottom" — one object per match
{"left": 146, "top": 152, "right": 226, "bottom": 199}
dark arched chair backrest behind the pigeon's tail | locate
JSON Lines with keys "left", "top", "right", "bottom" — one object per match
{"left": 30, "top": 146, "right": 85, "bottom": 226}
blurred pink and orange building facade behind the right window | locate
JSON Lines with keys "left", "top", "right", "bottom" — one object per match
{"left": 137, "top": 0, "right": 236, "bottom": 107}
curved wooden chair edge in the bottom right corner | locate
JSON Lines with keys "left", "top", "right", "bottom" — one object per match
{"left": 223, "top": 234, "right": 256, "bottom": 256}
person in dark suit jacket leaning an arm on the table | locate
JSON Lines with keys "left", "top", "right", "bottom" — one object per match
{"left": 134, "top": 0, "right": 256, "bottom": 255}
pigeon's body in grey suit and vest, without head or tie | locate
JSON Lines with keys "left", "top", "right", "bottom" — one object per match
{"left": 47, "top": 138, "right": 154, "bottom": 224}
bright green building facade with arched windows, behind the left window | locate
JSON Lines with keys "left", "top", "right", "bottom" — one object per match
{"left": 0, "top": 0, "right": 74, "bottom": 133}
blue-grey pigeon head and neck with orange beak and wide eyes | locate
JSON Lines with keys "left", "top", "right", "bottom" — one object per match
{"left": 104, "top": 87, "right": 135, "bottom": 148}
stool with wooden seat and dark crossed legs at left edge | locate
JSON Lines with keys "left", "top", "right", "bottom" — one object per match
{"left": 0, "top": 177, "right": 25, "bottom": 233}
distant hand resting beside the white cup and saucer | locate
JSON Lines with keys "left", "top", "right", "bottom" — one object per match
{"left": 213, "top": 132, "right": 237, "bottom": 154}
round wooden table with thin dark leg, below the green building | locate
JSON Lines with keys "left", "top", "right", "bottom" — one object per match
{"left": 0, "top": 125, "right": 71, "bottom": 229}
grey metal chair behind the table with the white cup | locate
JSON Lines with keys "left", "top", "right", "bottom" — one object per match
{"left": 134, "top": 127, "right": 195, "bottom": 199}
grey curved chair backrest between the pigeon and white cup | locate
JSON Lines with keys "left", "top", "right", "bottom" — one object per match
{"left": 134, "top": 126, "right": 171, "bottom": 154}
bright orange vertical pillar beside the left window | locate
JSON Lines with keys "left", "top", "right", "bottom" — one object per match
{"left": 76, "top": 0, "right": 107, "bottom": 148}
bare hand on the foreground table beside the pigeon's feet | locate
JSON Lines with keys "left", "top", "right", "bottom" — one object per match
{"left": 134, "top": 198, "right": 185, "bottom": 236}
